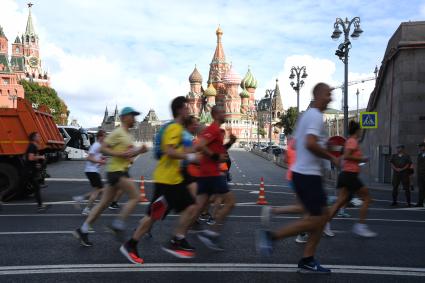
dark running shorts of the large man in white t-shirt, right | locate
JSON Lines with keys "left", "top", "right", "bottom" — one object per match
{"left": 292, "top": 172, "right": 327, "bottom": 216}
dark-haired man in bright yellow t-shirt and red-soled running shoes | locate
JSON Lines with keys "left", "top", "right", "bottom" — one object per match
{"left": 120, "top": 96, "right": 198, "bottom": 264}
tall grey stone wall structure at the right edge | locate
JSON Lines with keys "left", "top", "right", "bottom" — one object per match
{"left": 362, "top": 21, "right": 425, "bottom": 183}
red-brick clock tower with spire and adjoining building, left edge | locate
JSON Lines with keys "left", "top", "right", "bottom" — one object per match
{"left": 0, "top": 3, "right": 50, "bottom": 108}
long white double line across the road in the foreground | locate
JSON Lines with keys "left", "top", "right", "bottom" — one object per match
{"left": 0, "top": 263, "right": 425, "bottom": 277}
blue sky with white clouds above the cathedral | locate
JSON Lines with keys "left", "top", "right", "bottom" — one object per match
{"left": 0, "top": 0, "right": 425, "bottom": 127}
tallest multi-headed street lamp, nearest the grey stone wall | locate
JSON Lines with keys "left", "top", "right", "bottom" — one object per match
{"left": 331, "top": 17, "right": 363, "bottom": 137}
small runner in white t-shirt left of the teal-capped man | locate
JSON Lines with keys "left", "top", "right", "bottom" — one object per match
{"left": 73, "top": 130, "right": 106, "bottom": 216}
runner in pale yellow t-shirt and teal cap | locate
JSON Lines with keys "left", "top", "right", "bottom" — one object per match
{"left": 74, "top": 107, "right": 147, "bottom": 247}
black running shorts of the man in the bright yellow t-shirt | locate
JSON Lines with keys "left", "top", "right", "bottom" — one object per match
{"left": 147, "top": 182, "right": 195, "bottom": 217}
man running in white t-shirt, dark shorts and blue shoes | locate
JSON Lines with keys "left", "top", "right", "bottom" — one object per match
{"left": 258, "top": 83, "right": 338, "bottom": 273}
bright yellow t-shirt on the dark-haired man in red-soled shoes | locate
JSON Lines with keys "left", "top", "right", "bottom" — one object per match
{"left": 153, "top": 123, "right": 183, "bottom": 185}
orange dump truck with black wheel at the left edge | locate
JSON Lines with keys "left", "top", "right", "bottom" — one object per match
{"left": 0, "top": 98, "right": 64, "bottom": 200}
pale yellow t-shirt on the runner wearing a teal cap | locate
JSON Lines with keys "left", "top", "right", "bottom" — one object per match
{"left": 104, "top": 127, "right": 134, "bottom": 172}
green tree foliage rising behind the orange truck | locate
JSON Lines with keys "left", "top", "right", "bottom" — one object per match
{"left": 19, "top": 80, "right": 69, "bottom": 125}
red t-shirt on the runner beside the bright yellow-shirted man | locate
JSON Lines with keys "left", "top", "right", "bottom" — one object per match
{"left": 200, "top": 123, "right": 226, "bottom": 177}
